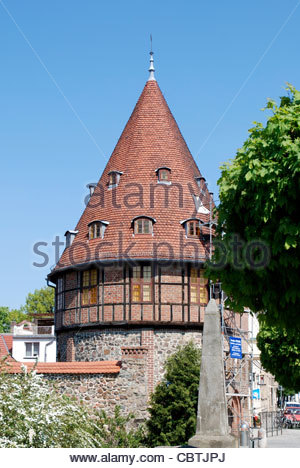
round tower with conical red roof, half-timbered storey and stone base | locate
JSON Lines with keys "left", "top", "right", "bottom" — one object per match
{"left": 48, "top": 52, "right": 214, "bottom": 390}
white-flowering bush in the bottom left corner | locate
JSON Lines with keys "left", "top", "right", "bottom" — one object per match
{"left": 0, "top": 361, "right": 143, "bottom": 448}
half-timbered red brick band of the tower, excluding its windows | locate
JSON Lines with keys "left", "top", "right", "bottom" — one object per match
{"left": 56, "top": 263, "right": 205, "bottom": 330}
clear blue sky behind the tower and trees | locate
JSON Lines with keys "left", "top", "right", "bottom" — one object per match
{"left": 0, "top": 0, "right": 300, "bottom": 307}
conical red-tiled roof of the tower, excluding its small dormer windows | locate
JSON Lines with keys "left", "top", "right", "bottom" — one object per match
{"left": 52, "top": 81, "right": 214, "bottom": 270}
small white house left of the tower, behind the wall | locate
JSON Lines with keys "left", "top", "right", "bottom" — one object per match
{"left": 12, "top": 320, "right": 56, "bottom": 362}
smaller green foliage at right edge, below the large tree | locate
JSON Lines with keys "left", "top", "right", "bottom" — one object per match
{"left": 257, "top": 324, "right": 300, "bottom": 393}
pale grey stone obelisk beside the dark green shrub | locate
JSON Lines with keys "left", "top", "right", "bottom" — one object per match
{"left": 188, "top": 299, "right": 238, "bottom": 448}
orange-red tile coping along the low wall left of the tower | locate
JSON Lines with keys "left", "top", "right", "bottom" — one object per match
{"left": 5, "top": 361, "right": 121, "bottom": 374}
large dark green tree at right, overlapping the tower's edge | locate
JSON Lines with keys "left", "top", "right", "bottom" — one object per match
{"left": 209, "top": 86, "right": 300, "bottom": 329}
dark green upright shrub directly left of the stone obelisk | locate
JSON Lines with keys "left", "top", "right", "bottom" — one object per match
{"left": 146, "top": 342, "right": 201, "bottom": 447}
